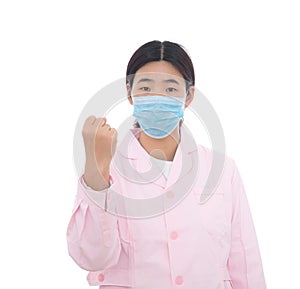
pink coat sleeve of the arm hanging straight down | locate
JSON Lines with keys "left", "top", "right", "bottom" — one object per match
{"left": 228, "top": 162, "right": 266, "bottom": 289}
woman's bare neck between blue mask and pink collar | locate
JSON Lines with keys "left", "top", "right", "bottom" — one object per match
{"left": 139, "top": 126, "right": 180, "bottom": 161}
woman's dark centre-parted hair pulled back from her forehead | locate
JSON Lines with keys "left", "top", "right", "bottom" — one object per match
{"left": 126, "top": 40, "right": 195, "bottom": 127}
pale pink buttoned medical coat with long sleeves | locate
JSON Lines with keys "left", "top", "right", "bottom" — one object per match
{"left": 67, "top": 126, "right": 266, "bottom": 289}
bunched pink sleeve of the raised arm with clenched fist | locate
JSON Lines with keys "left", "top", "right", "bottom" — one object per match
{"left": 67, "top": 175, "right": 121, "bottom": 271}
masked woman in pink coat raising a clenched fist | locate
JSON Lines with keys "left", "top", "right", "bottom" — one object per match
{"left": 67, "top": 41, "right": 266, "bottom": 289}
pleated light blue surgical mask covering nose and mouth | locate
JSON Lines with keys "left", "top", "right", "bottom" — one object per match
{"left": 132, "top": 95, "right": 185, "bottom": 138}
